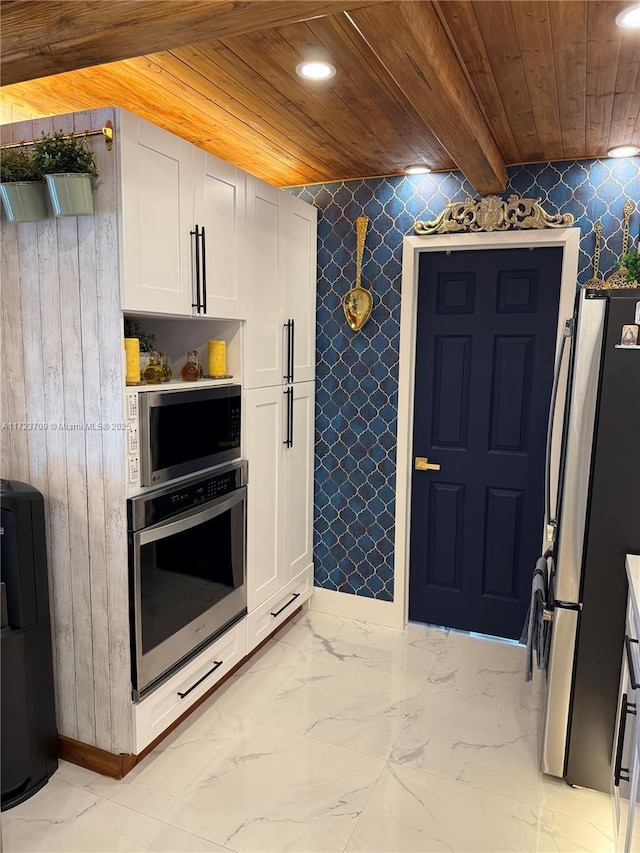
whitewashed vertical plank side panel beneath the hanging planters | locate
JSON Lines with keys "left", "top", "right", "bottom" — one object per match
{"left": 0, "top": 109, "right": 132, "bottom": 753}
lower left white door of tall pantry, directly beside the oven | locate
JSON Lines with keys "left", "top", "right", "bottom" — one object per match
{"left": 244, "top": 387, "right": 283, "bottom": 613}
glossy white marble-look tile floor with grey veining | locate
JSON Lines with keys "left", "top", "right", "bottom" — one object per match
{"left": 2, "top": 611, "right": 613, "bottom": 853}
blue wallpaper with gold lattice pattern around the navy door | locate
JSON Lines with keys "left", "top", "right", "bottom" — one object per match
{"left": 290, "top": 157, "right": 640, "bottom": 601}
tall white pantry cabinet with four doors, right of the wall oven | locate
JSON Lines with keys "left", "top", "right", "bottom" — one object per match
{"left": 245, "top": 178, "right": 317, "bottom": 648}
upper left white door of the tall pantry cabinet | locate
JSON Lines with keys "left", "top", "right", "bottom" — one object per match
{"left": 246, "top": 175, "right": 285, "bottom": 388}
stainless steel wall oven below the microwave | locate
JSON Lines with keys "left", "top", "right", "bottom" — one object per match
{"left": 128, "top": 462, "right": 247, "bottom": 700}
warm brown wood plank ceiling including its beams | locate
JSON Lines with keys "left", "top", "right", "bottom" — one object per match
{"left": 0, "top": 0, "right": 640, "bottom": 194}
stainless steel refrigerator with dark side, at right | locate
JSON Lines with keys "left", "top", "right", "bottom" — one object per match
{"left": 541, "top": 289, "right": 640, "bottom": 791}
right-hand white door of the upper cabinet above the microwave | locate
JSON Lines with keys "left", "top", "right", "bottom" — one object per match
{"left": 194, "top": 149, "right": 246, "bottom": 319}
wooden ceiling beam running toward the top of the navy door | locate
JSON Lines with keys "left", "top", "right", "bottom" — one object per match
{"left": 348, "top": 0, "right": 506, "bottom": 195}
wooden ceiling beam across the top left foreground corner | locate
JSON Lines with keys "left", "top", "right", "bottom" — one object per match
{"left": 0, "top": 0, "right": 385, "bottom": 85}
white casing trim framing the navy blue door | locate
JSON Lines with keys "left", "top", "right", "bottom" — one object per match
{"left": 387, "top": 227, "right": 580, "bottom": 628}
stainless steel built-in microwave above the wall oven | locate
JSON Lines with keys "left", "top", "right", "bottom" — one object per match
{"left": 139, "top": 385, "right": 241, "bottom": 486}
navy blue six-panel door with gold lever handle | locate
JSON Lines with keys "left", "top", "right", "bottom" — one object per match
{"left": 409, "top": 248, "right": 562, "bottom": 638}
